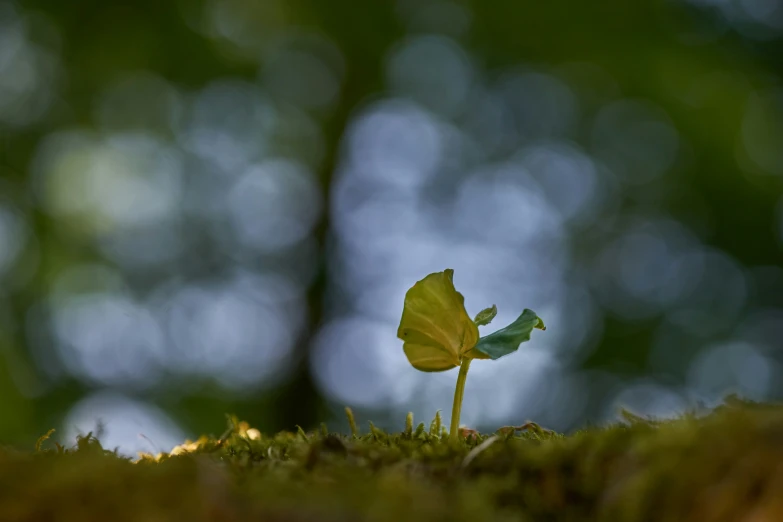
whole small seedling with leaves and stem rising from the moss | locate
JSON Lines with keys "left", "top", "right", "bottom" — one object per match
{"left": 397, "top": 268, "right": 546, "bottom": 439}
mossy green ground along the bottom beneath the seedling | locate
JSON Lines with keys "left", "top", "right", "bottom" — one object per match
{"left": 0, "top": 394, "right": 783, "bottom": 522}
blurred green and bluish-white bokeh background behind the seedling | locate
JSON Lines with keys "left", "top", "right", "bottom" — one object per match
{"left": 0, "top": 0, "right": 783, "bottom": 454}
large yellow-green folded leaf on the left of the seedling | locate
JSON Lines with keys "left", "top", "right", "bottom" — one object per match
{"left": 397, "top": 269, "right": 479, "bottom": 372}
